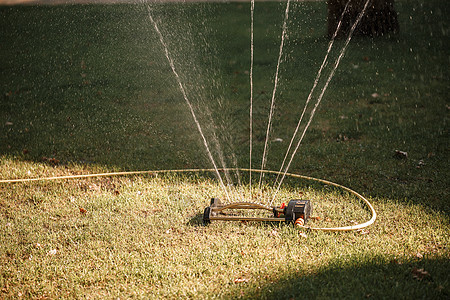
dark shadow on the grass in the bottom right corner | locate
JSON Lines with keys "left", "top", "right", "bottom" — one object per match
{"left": 225, "top": 257, "right": 450, "bottom": 299}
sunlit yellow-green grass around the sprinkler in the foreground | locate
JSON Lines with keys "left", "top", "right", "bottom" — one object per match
{"left": 0, "top": 159, "right": 450, "bottom": 298}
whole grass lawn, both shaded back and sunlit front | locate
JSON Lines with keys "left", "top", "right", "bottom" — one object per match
{"left": 0, "top": 1, "right": 450, "bottom": 299}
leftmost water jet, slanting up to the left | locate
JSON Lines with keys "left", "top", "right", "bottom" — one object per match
{"left": 147, "top": 4, "right": 230, "bottom": 201}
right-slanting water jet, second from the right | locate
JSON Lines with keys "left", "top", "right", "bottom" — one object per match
{"left": 274, "top": 0, "right": 350, "bottom": 187}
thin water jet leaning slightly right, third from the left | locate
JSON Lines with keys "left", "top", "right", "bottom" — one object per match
{"left": 258, "top": 0, "right": 291, "bottom": 188}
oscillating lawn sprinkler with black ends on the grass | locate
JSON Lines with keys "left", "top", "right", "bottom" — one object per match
{"left": 203, "top": 198, "right": 312, "bottom": 226}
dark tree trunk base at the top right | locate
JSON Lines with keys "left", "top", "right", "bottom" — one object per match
{"left": 327, "top": 0, "right": 399, "bottom": 37}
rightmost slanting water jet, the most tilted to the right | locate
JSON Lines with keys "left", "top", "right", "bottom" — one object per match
{"left": 269, "top": 0, "right": 370, "bottom": 206}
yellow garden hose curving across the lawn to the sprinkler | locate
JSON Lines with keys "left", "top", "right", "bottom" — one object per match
{"left": 0, "top": 168, "right": 377, "bottom": 232}
